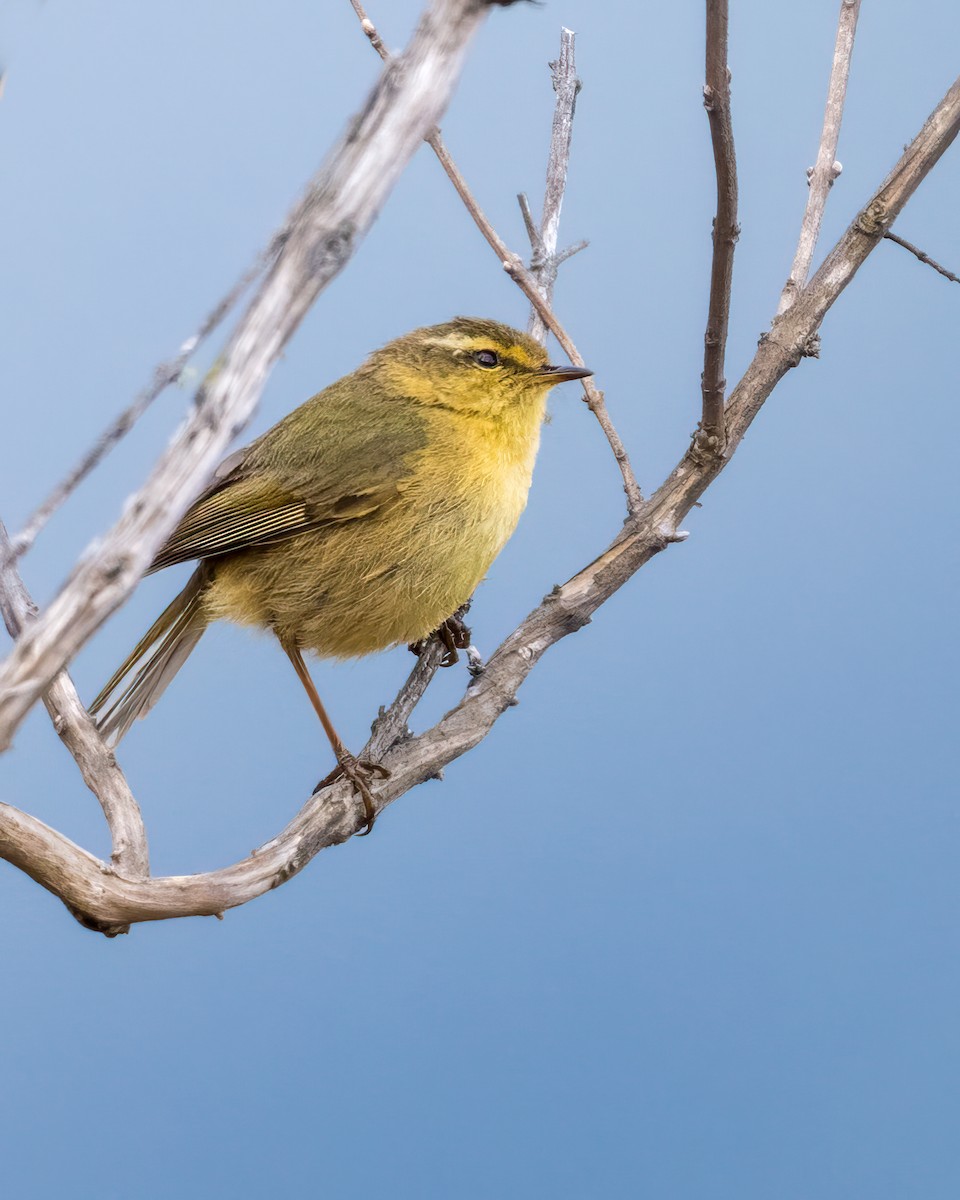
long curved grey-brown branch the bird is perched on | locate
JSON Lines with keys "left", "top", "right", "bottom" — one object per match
{"left": 0, "top": 70, "right": 960, "bottom": 932}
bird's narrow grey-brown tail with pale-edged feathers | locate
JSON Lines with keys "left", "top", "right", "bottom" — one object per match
{"left": 90, "top": 564, "right": 210, "bottom": 746}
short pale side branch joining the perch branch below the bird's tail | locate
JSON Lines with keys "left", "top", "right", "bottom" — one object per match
{"left": 0, "top": 521, "right": 150, "bottom": 880}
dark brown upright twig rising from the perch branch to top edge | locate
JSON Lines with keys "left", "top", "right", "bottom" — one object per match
{"left": 698, "top": 0, "right": 740, "bottom": 450}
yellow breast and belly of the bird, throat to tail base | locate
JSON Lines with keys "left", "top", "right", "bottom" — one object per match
{"left": 210, "top": 397, "right": 545, "bottom": 658}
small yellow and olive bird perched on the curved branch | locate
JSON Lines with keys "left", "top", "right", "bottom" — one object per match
{"left": 90, "top": 317, "right": 592, "bottom": 824}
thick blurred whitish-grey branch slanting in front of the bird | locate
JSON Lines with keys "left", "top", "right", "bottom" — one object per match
{"left": 0, "top": 0, "right": 499, "bottom": 750}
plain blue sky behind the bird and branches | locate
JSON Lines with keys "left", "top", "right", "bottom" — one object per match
{"left": 0, "top": 0, "right": 960, "bottom": 1200}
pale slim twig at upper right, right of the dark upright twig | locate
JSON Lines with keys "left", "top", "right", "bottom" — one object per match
{"left": 776, "top": 0, "right": 860, "bottom": 313}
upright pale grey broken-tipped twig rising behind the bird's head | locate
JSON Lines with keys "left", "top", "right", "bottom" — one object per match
{"left": 521, "top": 28, "right": 582, "bottom": 344}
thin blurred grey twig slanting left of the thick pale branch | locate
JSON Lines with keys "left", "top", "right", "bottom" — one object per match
{"left": 6, "top": 249, "right": 280, "bottom": 565}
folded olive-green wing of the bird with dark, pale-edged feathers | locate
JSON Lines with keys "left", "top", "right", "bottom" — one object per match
{"left": 150, "top": 384, "right": 425, "bottom": 571}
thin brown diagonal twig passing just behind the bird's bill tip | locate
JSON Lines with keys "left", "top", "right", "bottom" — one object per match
{"left": 350, "top": 0, "right": 643, "bottom": 517}
